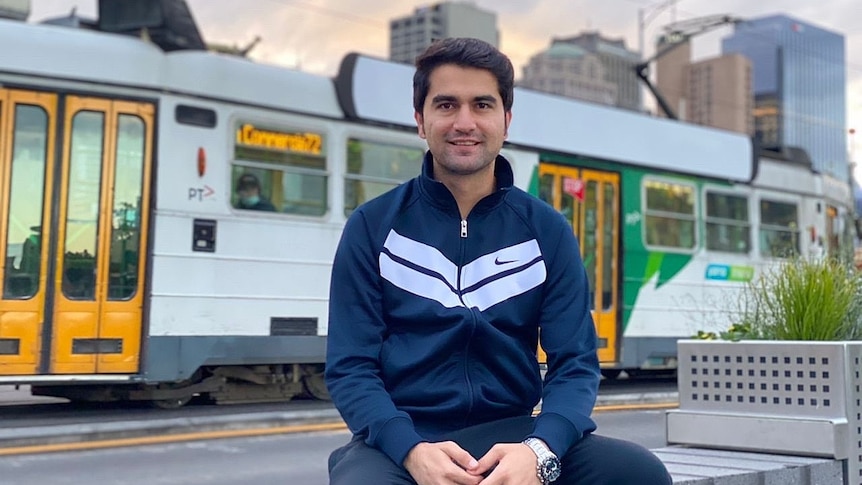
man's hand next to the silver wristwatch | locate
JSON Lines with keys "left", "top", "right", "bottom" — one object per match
{"left": 471, "top": 443, "right": 542, "bottom": 485}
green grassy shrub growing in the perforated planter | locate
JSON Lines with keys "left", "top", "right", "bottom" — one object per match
{"left": 732, "top": 257, "right": 862, "bottom": 340}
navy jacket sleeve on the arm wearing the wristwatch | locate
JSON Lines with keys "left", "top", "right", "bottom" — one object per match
{"left": 531, "top": 217, "right": 601, "bottom": 456}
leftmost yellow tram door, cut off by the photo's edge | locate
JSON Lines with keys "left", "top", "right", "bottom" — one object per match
{"left": 0, "top": 88, "right": 57, "bottom": 376}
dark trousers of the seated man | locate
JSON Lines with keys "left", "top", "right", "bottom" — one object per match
{"left": 329, "top": 416, "right": 672, "bottom": 485}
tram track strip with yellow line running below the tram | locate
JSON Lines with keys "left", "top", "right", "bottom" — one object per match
{"left": 0, "top": 378, "right": 677, "bottom": 456}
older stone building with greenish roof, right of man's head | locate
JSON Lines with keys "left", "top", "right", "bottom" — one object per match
{"left": 518, "top": 42, "right": 617, "bottom": 106}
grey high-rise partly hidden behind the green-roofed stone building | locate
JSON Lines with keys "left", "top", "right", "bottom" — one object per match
{"left": 554, "top": 32, "right": 643, "bottom": 111}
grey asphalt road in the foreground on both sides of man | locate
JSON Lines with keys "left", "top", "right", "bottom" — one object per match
{"left": 0, "top": 410, "right": 665, "bottom": 485}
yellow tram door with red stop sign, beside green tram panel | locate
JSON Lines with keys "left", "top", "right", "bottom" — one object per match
{"left": 539, "top": 163, "right": 620, "bottom": 364}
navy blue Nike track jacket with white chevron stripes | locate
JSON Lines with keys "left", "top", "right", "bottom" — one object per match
{"left": 325, "top": 153, "right": 599, "bottom": 465}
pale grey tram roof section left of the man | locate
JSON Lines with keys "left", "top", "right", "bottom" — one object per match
{"left": 0, "top": 20, "right": 342, "bottom": 118}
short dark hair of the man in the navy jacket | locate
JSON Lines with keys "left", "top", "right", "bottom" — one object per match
{"left": 413, "top": 37, "right": 515, "bottom": 113}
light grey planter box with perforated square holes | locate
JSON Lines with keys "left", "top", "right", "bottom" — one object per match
{"left": 667, "top": 340, "right": 862, "bottom": 485}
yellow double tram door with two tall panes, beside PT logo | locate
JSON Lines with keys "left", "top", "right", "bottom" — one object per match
{"left": 50, "top": 96, "right": 154, "bottom": 374}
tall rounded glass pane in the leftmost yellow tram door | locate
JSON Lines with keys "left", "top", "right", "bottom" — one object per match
{"left": 3, "top": 105, "right": 48, "bottom": 299}
